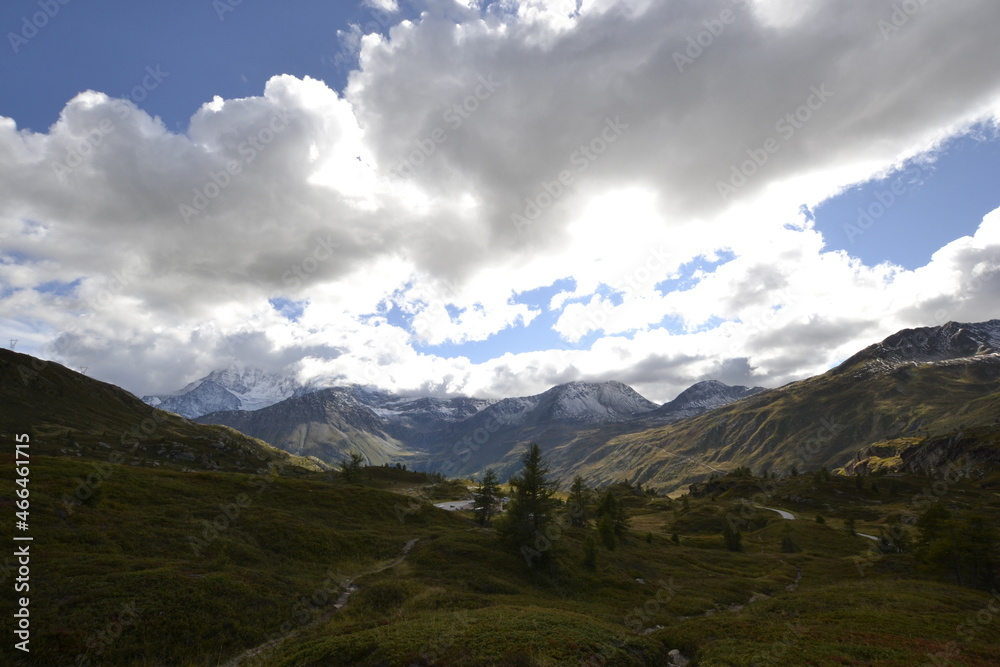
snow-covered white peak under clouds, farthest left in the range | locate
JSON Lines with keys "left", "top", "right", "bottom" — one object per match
{"left": 142, "top": 366, "right": 309, "bottom": 419}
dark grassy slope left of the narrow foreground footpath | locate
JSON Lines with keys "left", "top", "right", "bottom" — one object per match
{"left": 0, "top": 452, "right": 454, "bottom": 665}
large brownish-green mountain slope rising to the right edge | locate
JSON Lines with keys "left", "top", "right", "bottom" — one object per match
{"left": 568, "top": 320, "right": 1000, "bottom": 490}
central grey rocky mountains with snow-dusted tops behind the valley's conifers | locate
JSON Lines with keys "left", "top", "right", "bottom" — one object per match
{"left": 198, "top": 382, "right": 657, "bottom": 474}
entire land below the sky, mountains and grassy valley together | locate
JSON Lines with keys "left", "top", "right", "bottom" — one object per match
{"left": 0, "top": 320, "right": 1000, "bottom": 667}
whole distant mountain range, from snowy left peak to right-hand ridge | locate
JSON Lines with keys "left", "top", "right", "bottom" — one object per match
{"left": 166, "top": 320, "right": 1000, "bottom": 491}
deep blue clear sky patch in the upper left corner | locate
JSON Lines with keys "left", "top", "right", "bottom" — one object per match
{"left": 0, "top": 0, "right": 405, "bottom": 131}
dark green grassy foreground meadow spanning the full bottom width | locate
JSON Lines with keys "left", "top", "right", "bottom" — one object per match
{"left": 0, "top": 454, "right": 1000, "bottom": 666}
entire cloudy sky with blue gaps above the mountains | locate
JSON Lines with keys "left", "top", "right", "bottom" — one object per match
{"left": 0, "top": 0, "right": 1000, "bottom": 402}
